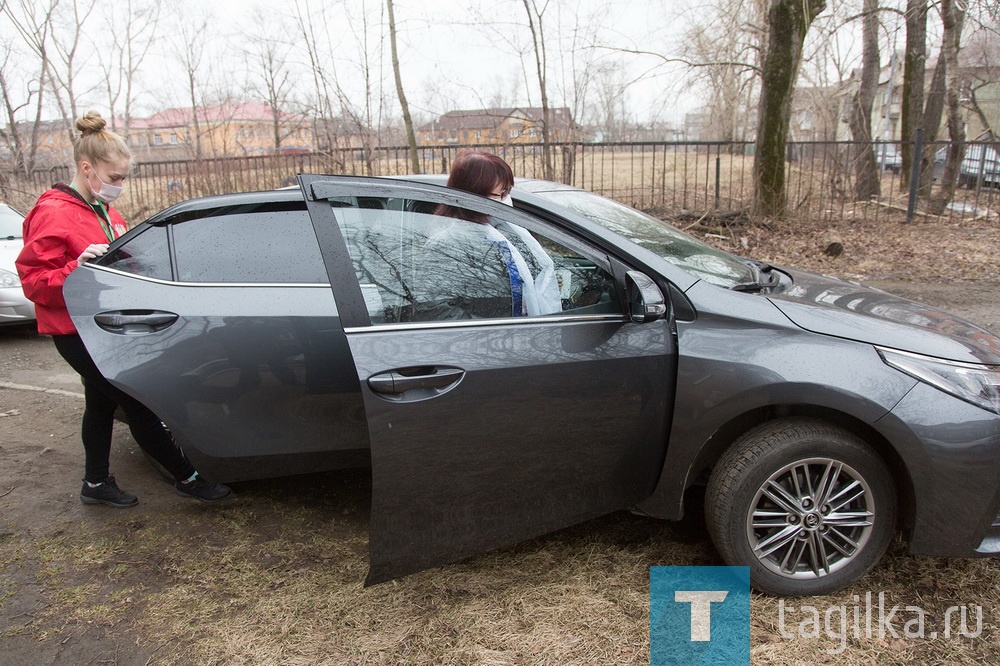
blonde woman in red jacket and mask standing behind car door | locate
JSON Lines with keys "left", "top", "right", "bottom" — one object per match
{"left": 16, "top": 111, "right": 230, "bottom": 507}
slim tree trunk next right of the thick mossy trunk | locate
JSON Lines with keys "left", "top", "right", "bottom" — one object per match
{"left": 848, "top": 0, "right": 881, "bottom": 201}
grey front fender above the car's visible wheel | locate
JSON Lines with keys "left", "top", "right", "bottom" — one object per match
{"left": 636, "top": 282, "right": 917, "bottom": 520}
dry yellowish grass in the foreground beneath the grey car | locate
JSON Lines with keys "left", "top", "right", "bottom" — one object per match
{"left": 7, "top": 474, "right": 1000, "bottom": 666}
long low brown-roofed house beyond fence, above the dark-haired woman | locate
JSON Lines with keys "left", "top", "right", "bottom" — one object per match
{"left": 417, "top": 107, "right": 580, "bottom": 146}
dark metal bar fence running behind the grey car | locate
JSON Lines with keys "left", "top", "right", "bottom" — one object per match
{"left": 0, "top": 142, "right": 1000, "bottom": 221}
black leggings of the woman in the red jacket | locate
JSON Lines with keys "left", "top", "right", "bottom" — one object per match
{"left": 52, "top": 334, "right": 194, "bottom": 483}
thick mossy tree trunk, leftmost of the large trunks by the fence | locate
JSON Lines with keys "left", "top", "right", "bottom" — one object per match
{"left": 753, "top": 0, "right": 826, "bottom": 217}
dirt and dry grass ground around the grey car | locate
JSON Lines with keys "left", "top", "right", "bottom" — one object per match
{"left": 0, "top": 198, "right": 1000, "bottom": 666}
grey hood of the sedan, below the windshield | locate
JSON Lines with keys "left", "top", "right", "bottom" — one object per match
{"left": 767, "top": 268, "right": 1000, "bottom": 365}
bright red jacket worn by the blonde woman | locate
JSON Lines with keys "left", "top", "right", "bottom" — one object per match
{"left": 14, "top": 184, "right": 128, "bottom": 335}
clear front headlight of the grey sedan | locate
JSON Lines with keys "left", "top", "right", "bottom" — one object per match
{"left": 878, "top": 348, "right": 1000, "bottom": 414}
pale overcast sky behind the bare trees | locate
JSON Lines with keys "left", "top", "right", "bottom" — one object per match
{"left": 0, "top": 0, "right": 916, "bottom": 123}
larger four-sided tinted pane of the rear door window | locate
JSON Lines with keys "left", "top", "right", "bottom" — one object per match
{"left": 173, "top": 210, "right": 329, "bottom": 284}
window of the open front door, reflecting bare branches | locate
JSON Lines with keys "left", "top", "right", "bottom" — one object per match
{"left": 331, "top": 199, "right": 621, "bottom": 324}
